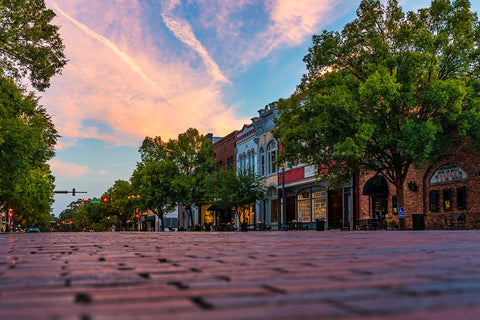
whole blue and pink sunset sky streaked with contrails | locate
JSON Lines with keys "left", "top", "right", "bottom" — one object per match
{"left": 40, "top": 0, "right": 480, "bottom": 216}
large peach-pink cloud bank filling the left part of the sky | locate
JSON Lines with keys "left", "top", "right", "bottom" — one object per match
{"left": 42, "top": 0, "right": 244, "bottom": 145}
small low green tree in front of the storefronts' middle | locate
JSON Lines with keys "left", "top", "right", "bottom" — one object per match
{"left": 211, "top": 170, "right": 265, "bottom": 229}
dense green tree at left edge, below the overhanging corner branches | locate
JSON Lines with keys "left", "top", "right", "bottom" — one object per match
{"left": 0, "top": 77, "right": 58, "bottom": 226}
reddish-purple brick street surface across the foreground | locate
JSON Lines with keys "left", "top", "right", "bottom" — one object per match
{"left": 0, "top": 231, "right": 480, "bottom": 320}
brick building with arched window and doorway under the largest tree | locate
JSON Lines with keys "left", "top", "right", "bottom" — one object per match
{"left": 357, "top": 149, "right": 480, "bottom": 229}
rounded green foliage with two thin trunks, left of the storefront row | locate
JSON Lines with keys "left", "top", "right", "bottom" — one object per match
{"left": 131, "top": 128, "right": 214, "bottom": 225}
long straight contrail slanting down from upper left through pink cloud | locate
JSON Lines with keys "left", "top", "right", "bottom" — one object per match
{"left": 53, "top": 3, "right": 167, "bottom": 100}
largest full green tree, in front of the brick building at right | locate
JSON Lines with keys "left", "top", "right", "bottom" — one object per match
{"left": 275, "top": 0, "right": 480, "bottom": 226}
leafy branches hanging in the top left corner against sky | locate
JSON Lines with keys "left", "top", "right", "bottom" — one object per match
{"left": 0, "top": 0, "right": 67, "bottom": 91}
